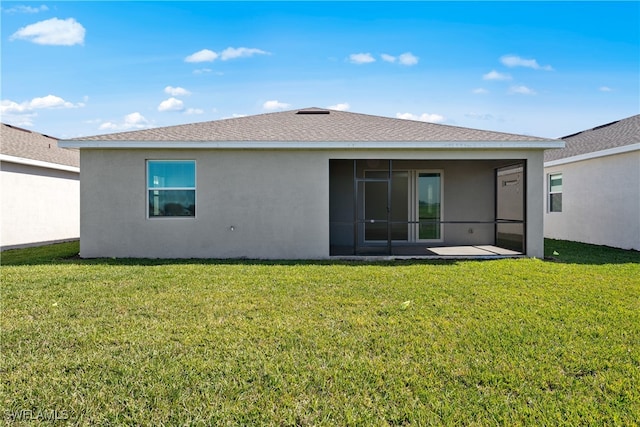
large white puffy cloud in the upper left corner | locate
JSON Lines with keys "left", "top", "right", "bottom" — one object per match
{"left": 9, "top": 18, "right": 86, "bottom": 46}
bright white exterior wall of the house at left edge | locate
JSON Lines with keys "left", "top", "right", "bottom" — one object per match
{"left": 0, "top": 161, "right": 80, "bottom": 249}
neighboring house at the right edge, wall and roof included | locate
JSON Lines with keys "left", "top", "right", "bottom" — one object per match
{"left": 544, "top": 115, "right": 640, "bottom": 250}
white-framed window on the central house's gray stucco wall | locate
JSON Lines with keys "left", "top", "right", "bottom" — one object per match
{"left": 147, "top": 160, "right": 196, "bottom": 218}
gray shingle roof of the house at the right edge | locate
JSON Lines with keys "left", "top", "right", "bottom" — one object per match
{"left": 544, "top": 114, "right": 640, "bottom": 162}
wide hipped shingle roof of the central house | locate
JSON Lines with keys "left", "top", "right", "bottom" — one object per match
{"left": 74, "top": 108, "right": 550, "bottom": 142}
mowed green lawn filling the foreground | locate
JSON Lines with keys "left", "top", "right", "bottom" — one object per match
{"left": 0, "top": 241, "right": 640, "bottom": 426}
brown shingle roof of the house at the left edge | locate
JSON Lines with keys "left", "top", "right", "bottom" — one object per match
{"left": 0, "top": 123, "right": 80, "bottom": 167}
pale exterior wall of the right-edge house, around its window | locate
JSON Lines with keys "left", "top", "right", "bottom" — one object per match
{"left": 544, "top": 151, "right": 640, "bottom": 250}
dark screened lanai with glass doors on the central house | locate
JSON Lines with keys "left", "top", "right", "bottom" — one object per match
{"left": 329, "top": 159, "right": 526, "bottom": 256}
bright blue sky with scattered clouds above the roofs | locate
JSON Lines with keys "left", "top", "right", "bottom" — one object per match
{"left": 0, "top": 1, "right": 640, "bottom": 138}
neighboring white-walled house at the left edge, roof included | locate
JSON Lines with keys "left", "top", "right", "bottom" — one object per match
{"left": 0, "top": 123, "right": 80, "bottom": 250}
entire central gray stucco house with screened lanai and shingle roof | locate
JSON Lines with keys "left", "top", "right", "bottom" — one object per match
{"left": 61, "top": 108, "right": 563, "bottom": 259}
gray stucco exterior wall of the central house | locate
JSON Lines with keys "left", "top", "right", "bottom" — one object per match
{"left": 80, "top": 149, "right": 543, "bottom": 259}
